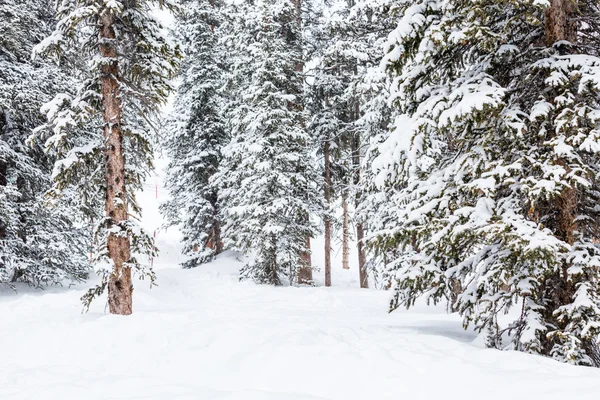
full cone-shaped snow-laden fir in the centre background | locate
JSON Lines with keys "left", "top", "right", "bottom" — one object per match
{"left": 215, "top": 0, "right": 322, "bottom": 285}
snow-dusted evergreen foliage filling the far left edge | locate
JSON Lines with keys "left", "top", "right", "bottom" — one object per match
{"left": 0, "top": 0, "right": 89, "bottom": 286}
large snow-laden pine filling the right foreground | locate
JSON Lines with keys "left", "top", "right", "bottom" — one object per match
{"left": 371, "top": 0, "right": 600, "bottom": 366}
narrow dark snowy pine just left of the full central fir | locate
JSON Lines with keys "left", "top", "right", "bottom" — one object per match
{"left": 161, "top": 0, "right": 228, "bottom": 268}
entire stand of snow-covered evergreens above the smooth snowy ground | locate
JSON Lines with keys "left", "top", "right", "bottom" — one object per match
{"left": 0, "top": 0, "right": 600, "bottom": 394}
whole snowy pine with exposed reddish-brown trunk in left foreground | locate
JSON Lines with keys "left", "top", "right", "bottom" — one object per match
{"left": 36, "top": 0, "right": 179, "bottom": 314}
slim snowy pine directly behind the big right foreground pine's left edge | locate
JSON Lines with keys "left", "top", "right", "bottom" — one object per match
{"left": 341, "top": 0, "right": 397, "bottom": 287}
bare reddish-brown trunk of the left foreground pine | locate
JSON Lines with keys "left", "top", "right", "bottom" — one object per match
{"left": 100, "top": 13, "right": 133, "bottom": 315}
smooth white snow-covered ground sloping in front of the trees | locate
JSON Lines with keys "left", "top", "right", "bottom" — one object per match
{"left": 0, "top": 254, "right": 600, "bottom": 400}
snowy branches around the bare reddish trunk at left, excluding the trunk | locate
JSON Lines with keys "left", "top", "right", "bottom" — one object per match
{"left": 35, "top": 0, "right": 179, "bottom": 303}
